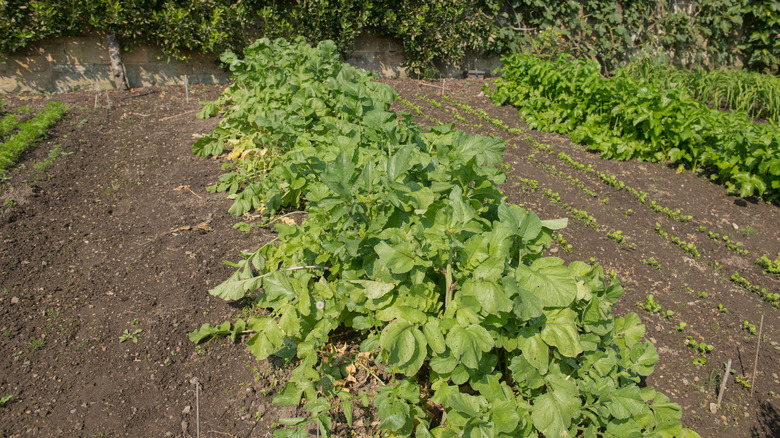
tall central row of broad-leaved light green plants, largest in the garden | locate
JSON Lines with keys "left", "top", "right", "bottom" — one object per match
{"left": 190, "top": 40, "right": 698, "bottom": 437}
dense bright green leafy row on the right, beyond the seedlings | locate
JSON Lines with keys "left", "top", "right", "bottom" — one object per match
{"left": 491, "top": 55, "right": 780, "bottom": 201}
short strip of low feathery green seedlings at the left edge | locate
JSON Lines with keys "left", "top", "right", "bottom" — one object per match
{"left": 0, "top": 102, "right": 68, "bottom": 174}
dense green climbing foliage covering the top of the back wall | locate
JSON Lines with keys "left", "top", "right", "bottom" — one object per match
{"left": 0, "top": 0, "right": 780, "bottom": 76}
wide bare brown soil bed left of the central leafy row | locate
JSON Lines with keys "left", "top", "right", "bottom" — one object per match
{"left": 0, "top": 88, "right": 284, "bottom": 437}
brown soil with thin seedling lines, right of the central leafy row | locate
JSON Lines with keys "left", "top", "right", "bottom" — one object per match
{"left": 389, "top": 80, "right": 780, "bottom": 438}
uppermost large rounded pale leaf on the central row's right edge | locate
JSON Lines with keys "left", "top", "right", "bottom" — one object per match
{"left": 516, "top": 257, "right": 577, "bottom": 307}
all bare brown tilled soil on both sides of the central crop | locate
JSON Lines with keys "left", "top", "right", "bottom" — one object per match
{"left": 0, "top": 80, "right": 780, "bottom": 438}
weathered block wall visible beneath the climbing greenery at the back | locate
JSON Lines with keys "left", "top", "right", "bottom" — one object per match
{"left": 0, "top": 34, "right": 500, "bottom": 93}
